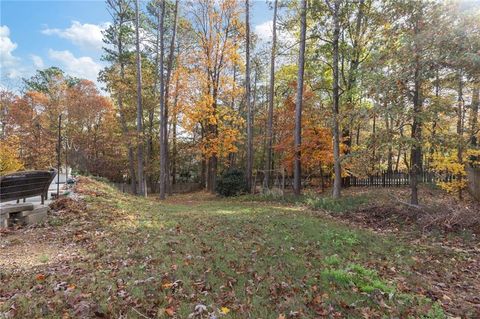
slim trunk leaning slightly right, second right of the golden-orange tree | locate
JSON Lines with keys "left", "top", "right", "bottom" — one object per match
{"left": 263, "top": 0, "right": 278, "bottom": 191}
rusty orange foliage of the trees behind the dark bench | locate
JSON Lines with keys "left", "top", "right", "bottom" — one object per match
{"left": 2, "top": 78, "right": 119, "bottom": 176}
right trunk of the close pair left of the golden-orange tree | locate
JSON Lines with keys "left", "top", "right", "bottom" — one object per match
{"left": 163, "top": 0, "right": 178, "bottom": 194}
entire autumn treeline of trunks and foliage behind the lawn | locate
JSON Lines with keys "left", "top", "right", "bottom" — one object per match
{"left": 1, "top": 0, "right": 480, "bottom": 204}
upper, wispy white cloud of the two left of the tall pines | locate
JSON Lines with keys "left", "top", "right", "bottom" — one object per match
{"left": 42, "top": 21, "right": 109, "bottom": 50}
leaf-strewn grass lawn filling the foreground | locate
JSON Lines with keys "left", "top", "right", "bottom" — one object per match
{"left": 0, "top": 178, "right": 475, "bottom": 319}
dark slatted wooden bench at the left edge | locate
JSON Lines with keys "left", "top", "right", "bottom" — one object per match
{"left": 0, "top": 170, "right": 57, "bottom": 204}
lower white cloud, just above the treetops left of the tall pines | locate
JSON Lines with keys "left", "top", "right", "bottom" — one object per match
{"left": 48, "top": 49, "right": 102, "bottom": 83}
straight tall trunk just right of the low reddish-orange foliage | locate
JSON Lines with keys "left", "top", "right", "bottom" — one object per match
{"left": 332, "top": 0, "right": 342, "bottom": 198}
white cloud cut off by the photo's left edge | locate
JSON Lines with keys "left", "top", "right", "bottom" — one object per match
{"left": 0, "top": 25, "right": 22, "bottom": 79}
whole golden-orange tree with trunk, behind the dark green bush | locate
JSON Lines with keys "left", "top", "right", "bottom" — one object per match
{"left": 190, "top": 0, "right": 241, "bottom": 192}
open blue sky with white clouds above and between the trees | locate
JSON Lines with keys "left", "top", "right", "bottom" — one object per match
{"left": 0, "top": 0, "right": 273, "bottom": 90}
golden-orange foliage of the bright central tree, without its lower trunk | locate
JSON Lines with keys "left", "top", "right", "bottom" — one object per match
{"left": 181, "top": 0, "right": 243, "bottom": 161}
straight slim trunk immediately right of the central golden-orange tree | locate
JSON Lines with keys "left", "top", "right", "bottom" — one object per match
{"left": 245, "top": 0, "right": 253, "bottom": 192}
